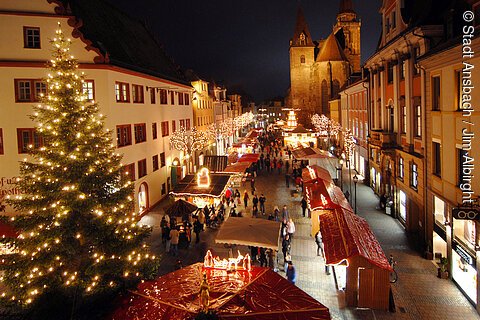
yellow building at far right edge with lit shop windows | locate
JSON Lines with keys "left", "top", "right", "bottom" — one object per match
{"left": 419, "top": 30, "right": 480, "bottom": 310}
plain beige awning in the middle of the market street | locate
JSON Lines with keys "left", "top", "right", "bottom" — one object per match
{"left": 215, "top": 217, "right": 280, "bottom": 250}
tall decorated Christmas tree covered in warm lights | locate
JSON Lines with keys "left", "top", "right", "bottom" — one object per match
{"left": 0, "top": 27, "right": 158, "bottom": 318}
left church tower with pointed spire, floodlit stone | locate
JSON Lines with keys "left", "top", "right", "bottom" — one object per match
{"left": 290, "top": 7, "right": 315, "bottom": 110}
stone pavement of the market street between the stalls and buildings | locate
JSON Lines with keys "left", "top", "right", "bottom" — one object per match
{"left": 142, "top": 162, "right": 480, "bottom": 320}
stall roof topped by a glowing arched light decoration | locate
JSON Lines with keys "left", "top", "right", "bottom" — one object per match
{"left": 170, "top": 173, "right": 231, "bottom": 197}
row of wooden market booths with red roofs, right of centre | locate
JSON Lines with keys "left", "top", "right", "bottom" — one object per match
{"left": 302, "top": 167, "right": 392, "bottom": 310}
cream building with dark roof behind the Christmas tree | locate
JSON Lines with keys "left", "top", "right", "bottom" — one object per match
{"left": 0, "top": 0, "right": 193, "bottom": 213}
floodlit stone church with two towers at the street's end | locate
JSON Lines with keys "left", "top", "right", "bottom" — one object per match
{"left": 286, "top": 0, "right": 361, "bottom": 123}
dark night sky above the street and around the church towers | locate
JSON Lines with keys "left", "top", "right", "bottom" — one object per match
{"left": 110, "top": 0, "right": 381, "bottom": 103}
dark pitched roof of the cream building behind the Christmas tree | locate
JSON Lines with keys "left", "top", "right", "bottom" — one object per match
{"left": 62, "top": 0, "right": 188, "bottom": 84}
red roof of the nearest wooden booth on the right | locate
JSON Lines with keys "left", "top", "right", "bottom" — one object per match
{"left": 320, "top": 207, "right": 391, "bottom": 270}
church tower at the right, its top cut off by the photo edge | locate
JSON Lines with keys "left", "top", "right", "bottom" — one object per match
{"left": 333, "top": 0, "right": 362, "bottom": 72}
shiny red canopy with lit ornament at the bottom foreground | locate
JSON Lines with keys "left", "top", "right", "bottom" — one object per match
{"left": 110, "top": 263, "right": 331, "bottom": 320}
